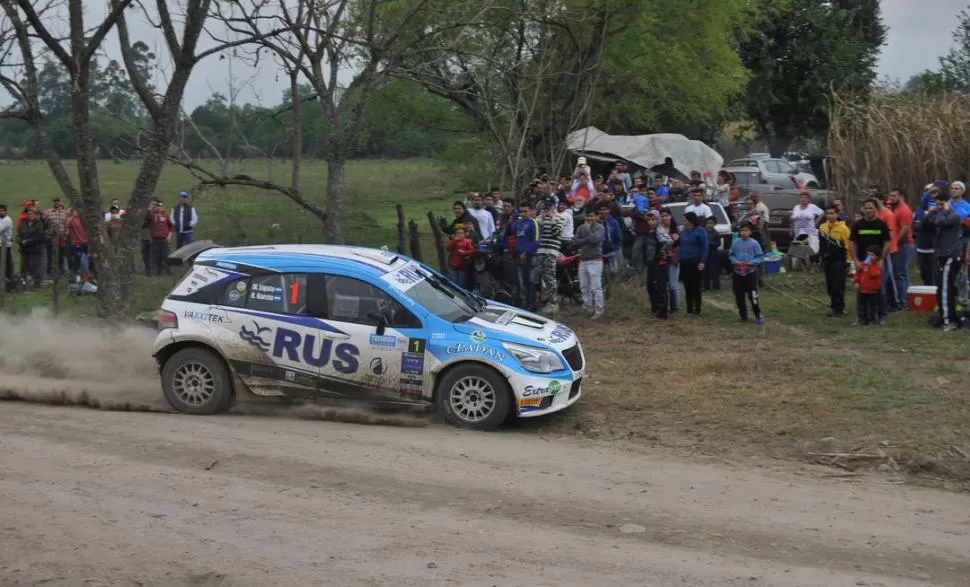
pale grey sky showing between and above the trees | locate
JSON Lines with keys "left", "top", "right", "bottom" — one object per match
{"left": 0, "top": 0, "right": 970, "bottom": 112}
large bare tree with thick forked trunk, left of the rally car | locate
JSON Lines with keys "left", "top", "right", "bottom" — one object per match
{"left": 0, "top": 0, "right": 278, "bottom": 316}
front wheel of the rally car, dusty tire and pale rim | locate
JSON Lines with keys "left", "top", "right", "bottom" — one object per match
{"left": 435, "top": 363, "right": 512, "bottom": 430}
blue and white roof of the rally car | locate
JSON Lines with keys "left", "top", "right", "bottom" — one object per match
{"left": 196, "top": 245, "right": 411, "bottom": 278}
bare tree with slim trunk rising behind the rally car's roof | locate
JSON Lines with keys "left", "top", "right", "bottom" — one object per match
{"left": 208, "top": 0, "right": 465, "bottom": 243}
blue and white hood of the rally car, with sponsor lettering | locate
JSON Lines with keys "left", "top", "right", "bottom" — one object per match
{"left": 454, "top": 302, "right": 578, "bottom": 351}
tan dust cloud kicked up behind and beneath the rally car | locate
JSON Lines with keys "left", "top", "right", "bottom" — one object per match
{"left": 0, "top": 310, "right": 430, "bottom": 426}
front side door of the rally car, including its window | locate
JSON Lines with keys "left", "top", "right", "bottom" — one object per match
{"left": 315, "top": 274, "right": 429, "bottom": 402}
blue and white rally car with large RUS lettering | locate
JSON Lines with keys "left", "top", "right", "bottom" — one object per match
{"left": 153, "top": 245, "right": 586, "bottom": 429}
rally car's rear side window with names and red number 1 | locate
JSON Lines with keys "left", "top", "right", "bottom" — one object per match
{"left": 221, "top": 273, "right": 307, "bottom": 314}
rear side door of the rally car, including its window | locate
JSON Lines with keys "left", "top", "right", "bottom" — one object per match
{"left": 218, "top": 273, "right": 323, "bottom": 397}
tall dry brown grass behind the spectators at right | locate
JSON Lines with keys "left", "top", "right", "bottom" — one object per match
{"left": 829, "top": 93, "right": 970, "bottom": 209}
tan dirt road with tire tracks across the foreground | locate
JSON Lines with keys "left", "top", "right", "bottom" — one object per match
{"left": 0, "top": 402, "right": 970, "bottom": 587}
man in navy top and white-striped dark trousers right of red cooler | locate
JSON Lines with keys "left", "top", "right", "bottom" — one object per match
{"left": 923, "top": 192, "right": 963, "bottom": 331}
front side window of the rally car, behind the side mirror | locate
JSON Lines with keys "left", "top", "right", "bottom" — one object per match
{"left": 323, "top": 275, "right": 421, "bottom": 328}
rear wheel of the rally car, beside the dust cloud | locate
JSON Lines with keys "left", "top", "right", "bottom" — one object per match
{"left": 162, "top": 347, "right": 232, "bottom": 415}
